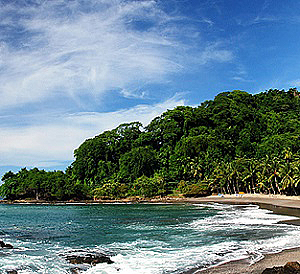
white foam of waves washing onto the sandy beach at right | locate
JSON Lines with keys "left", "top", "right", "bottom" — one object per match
{"left": 87, "top": 204, "right": 300, "bottom": 274}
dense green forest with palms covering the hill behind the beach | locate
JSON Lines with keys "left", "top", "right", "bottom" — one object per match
{"left": 0, "top": 89, "right": 300, "bottom": 200}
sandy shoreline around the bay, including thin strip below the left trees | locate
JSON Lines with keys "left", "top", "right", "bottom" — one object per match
{"left": 0, "top": 194, "right": 300, "bottom": 274}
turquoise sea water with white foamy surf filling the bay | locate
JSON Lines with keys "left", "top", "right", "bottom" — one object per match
{"left": 0, "top": 204, "right": 300, "bottom": 274}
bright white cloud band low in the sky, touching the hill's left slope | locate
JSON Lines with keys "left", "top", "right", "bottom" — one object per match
{"left": 0, "top": 95, "right": 184, "bottom": 167}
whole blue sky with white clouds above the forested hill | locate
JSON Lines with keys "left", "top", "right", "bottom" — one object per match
{"left": 0, "top": 0, "right": 300, "bottom": 176}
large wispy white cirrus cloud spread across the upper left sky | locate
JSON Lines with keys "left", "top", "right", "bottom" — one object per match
{"left": 0, "top": 0, "right": 232, "bottom": 108}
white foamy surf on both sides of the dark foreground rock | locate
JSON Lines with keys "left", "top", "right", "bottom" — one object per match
{"left": 0, "top": 204, "right": 300, "bottom": 274}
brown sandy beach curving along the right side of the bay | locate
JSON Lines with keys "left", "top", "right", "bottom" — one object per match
{"left": 183, "top": 194, "right": 300, "bottom": 274}
